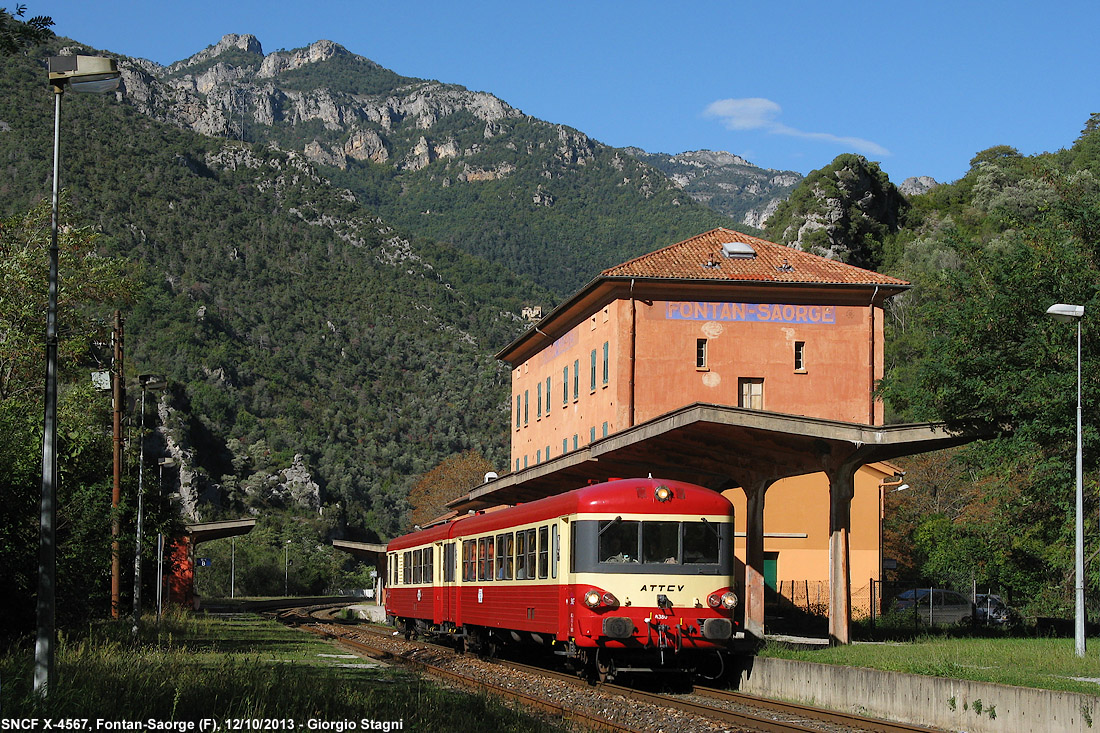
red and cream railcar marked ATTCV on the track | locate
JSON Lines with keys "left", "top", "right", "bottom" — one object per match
{"left": 386, "top": 479, "right": 738, "bottom": 677}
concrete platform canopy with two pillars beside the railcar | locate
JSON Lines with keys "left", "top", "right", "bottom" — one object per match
{"left": 448, "top": 403, "right": 991, "bottom": 644}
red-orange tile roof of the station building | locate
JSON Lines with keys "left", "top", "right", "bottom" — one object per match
{"left": 601, "top": 229, "right": 909, "bottom": 287}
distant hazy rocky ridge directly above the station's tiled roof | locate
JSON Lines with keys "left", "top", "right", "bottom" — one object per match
{"left": 626, "top": 147, "right": 802, "bottom": 229}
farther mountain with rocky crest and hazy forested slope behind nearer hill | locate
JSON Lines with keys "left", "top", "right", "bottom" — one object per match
{"left": 122, "top": 30, "right": 734, "bottom": 294}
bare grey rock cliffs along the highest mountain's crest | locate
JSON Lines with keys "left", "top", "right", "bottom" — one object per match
{"left": 120, "top": 34, "right": 525, "bottom": 171}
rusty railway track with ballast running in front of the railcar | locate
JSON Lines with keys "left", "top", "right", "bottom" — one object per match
{"left": 270, "top": 605, "right": 933, "bottom": 733}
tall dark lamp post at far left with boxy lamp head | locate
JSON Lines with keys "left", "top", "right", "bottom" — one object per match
{"left": 34, "top": 56, "right": 119, "bottom": 697}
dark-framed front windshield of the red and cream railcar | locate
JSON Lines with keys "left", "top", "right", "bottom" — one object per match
{"left": 573, "top": 517, "right": 733, "bottom": 575}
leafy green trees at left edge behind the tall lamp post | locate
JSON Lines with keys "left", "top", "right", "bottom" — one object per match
{"left": 0, "top": 201, "right": 168, "bottom": 634}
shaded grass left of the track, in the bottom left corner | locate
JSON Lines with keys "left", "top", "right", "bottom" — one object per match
{"left": 0, "top": 614, "right": 569, "bottom": 733}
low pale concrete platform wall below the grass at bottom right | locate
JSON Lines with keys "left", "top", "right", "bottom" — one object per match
{"left": 739, "top": 657, "right": 1100, "bottom": 733}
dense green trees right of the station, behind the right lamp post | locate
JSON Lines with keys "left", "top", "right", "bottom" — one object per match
{"left": 882, "top": 116, "right": 1100, "bottom": 617}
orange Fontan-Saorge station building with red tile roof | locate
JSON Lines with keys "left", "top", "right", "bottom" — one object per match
{"left": 497, "top": 229, "right": 910, "bottom": 612}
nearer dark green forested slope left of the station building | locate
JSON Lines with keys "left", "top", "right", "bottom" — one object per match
{"left": 0, "top": 42, "right": 550, "bottom": 536}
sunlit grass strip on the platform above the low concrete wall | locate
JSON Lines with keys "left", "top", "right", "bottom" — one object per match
{"left": 759, "top": 636, "right": 1100, "bottom": 694}
